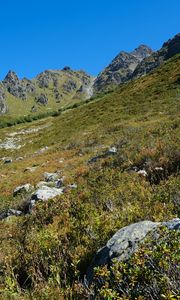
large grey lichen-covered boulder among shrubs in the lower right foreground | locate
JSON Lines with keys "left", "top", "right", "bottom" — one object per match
{"left": 87, "top": 219, "right": 180, "bottom": 283}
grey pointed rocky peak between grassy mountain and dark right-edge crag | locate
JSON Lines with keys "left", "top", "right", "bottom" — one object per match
{"left": 93, "top": 45, "right": 153, "bottom": 93}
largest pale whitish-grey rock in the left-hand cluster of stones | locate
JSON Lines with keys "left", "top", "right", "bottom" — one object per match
{"left": 31, "top": 185, "right": 63, "bottom": 201}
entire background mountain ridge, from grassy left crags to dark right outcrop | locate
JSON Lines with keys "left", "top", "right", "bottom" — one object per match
{"left": 0, "top": 34, "right": 180, "bottom": 115}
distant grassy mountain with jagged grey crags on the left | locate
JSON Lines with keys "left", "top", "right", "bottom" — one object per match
{"left": 0, "top": 67, "right": 94, "bottom": 115}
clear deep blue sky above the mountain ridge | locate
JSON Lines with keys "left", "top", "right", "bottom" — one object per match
{"left": 0, "top": 0, "right": 180, "bottom": 79}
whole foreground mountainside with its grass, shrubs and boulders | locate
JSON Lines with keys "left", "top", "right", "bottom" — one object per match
{"left": 0, "top": 55, "right": 180, "bottom": 300}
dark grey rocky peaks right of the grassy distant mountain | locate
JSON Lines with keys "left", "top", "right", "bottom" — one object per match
{"left": 93, "top": 34, "right": 180, "bottom": 94}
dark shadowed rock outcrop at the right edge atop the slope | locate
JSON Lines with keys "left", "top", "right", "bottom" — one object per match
{"left": 131, "top": 34, "right": 180, "bottom": 78}
